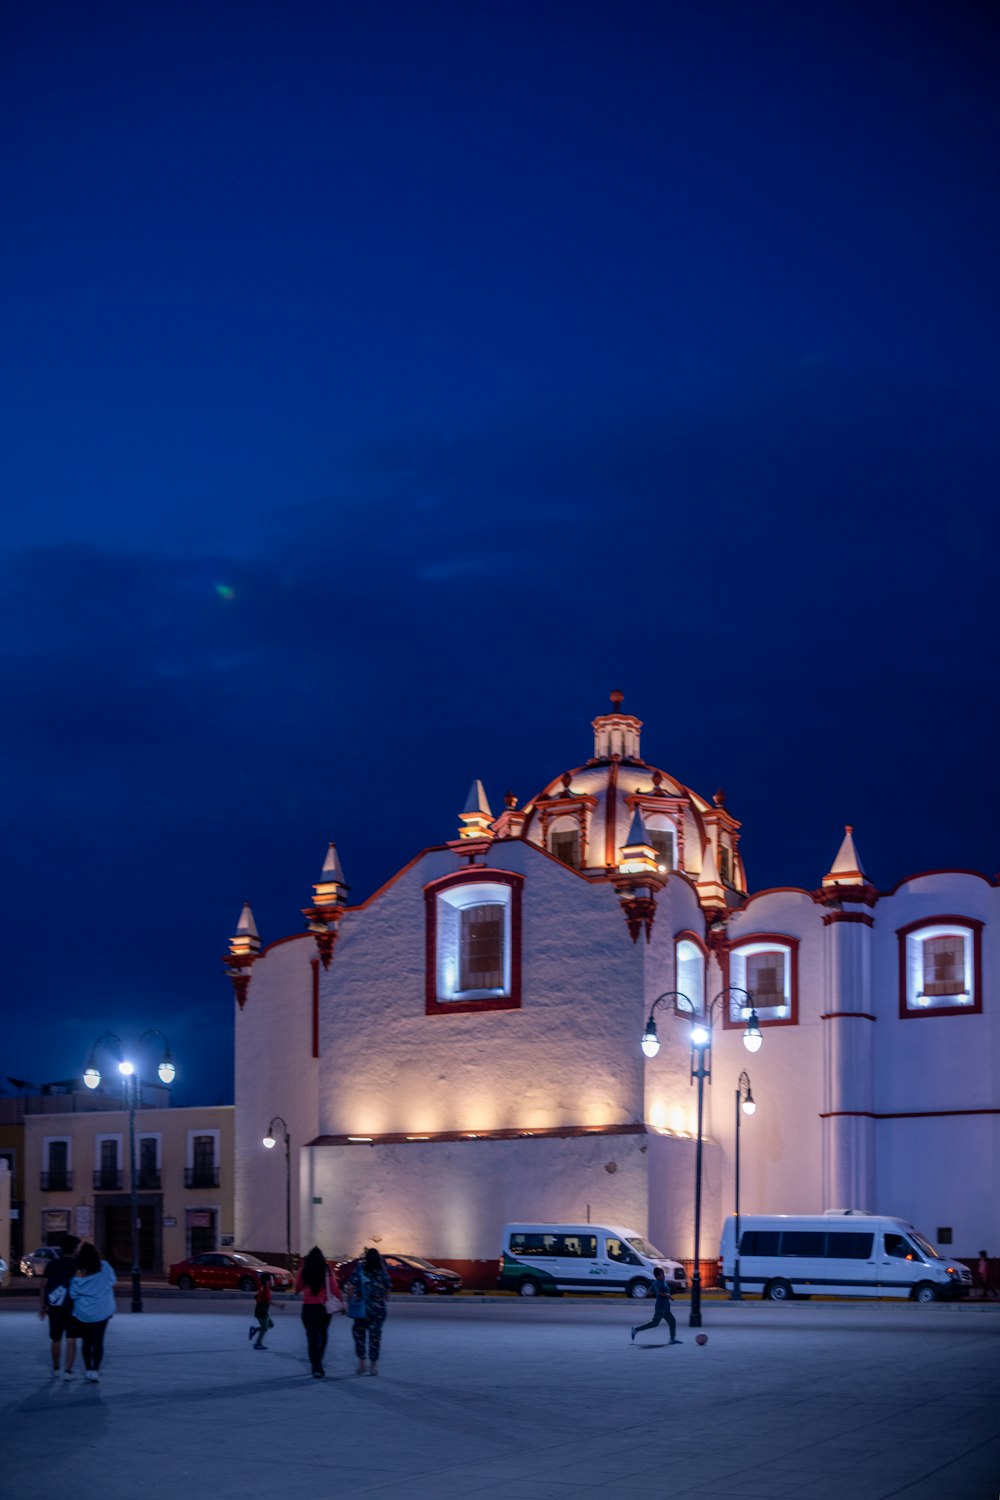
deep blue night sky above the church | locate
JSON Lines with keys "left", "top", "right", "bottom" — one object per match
{"left": 0, "top": 0, "right": 1000, "bottom": 1103}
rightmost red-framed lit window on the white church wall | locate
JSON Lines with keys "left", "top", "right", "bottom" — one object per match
{"left": 898, "top": 917, "right": 982, "bottom": 1016}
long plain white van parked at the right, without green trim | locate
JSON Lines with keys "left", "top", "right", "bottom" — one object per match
{"left": 720, "top": 1209, "right": 972, "bottom": 1302}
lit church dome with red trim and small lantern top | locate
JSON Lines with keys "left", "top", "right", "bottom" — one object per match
{"left": 522, "top": 693, "right": 747, "bottom": 893}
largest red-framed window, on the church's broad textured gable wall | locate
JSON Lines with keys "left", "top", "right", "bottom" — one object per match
{"left": 424, "top": 869, "right": 522, "bottom": 1016}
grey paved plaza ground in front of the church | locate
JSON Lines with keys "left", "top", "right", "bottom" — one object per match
{"left": 0, "top": 1295, "right": 1000, "bottom": 1500}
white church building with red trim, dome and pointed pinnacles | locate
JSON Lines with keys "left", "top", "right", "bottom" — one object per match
{"left": 226, "top": 693, "right": 1000, "bottom": 1286}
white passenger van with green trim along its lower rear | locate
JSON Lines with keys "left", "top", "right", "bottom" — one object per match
{"left": 496, "top": 1224, "right": 688, "bottom": 1298}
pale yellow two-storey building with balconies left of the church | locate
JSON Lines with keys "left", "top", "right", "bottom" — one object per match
{"left": 24, "top": 1104, "right": 234, "bottom": 1275}
